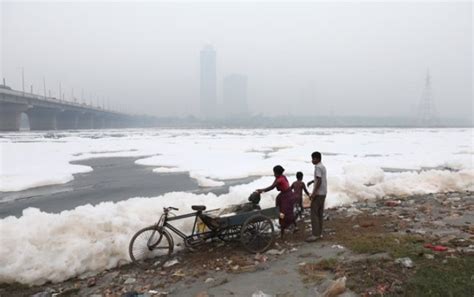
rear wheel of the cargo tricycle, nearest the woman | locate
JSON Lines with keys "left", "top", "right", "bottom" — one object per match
{"left": 240, "top": 214, "right": 275, "bottom": 253}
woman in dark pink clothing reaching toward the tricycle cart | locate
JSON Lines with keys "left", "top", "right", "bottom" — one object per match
{"left": 257, "top": 165, "right": 295, "bottom": 237}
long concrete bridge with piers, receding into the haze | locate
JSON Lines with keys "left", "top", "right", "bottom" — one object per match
{"left": 0, "top": 85, "right": 144, "bottom": 131}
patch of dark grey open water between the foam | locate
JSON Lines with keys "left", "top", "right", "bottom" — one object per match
{"left": 0, "top": 157, "right": 254, "bottom": 218}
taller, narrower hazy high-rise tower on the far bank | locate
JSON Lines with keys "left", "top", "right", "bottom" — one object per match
{"left": 200, "top": 45, "right": 217, "bottom": 118}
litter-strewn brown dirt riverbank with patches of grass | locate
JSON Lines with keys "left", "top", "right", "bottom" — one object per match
{"left": 0, "top": 192, "right": 474, "bottom": 297}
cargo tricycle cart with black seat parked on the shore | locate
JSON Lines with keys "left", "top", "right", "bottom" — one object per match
{"left": 129, "top": 202, "right": 278, "bottom": 265}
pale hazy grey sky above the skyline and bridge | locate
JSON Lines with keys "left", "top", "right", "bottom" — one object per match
{"left": 0, "top": 2, "right": 473, "bottom": 117}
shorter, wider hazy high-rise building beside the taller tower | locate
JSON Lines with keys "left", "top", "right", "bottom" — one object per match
{"left": 222, "top": 74, "right": 248, "bottom": 116}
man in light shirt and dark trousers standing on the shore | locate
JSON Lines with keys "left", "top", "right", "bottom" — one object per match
{"left": 306, "top": 152, "right": 328, "bottom": 242}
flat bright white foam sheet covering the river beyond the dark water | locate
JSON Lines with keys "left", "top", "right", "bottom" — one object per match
{"left": 0, "top": 129, "right": 474, "bottom": 191}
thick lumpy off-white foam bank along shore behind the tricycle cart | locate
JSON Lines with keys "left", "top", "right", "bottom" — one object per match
{"left": 0, "top": 180, "right": 274, "bottom": 284}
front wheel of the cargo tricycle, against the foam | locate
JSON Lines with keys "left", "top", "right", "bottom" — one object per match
{"left": 128, "top": 226, "right": 174, "bottom": 266}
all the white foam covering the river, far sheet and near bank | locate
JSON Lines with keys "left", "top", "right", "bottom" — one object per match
{"left": 0, "top": 129, "right": 474, "bottom": 284}
